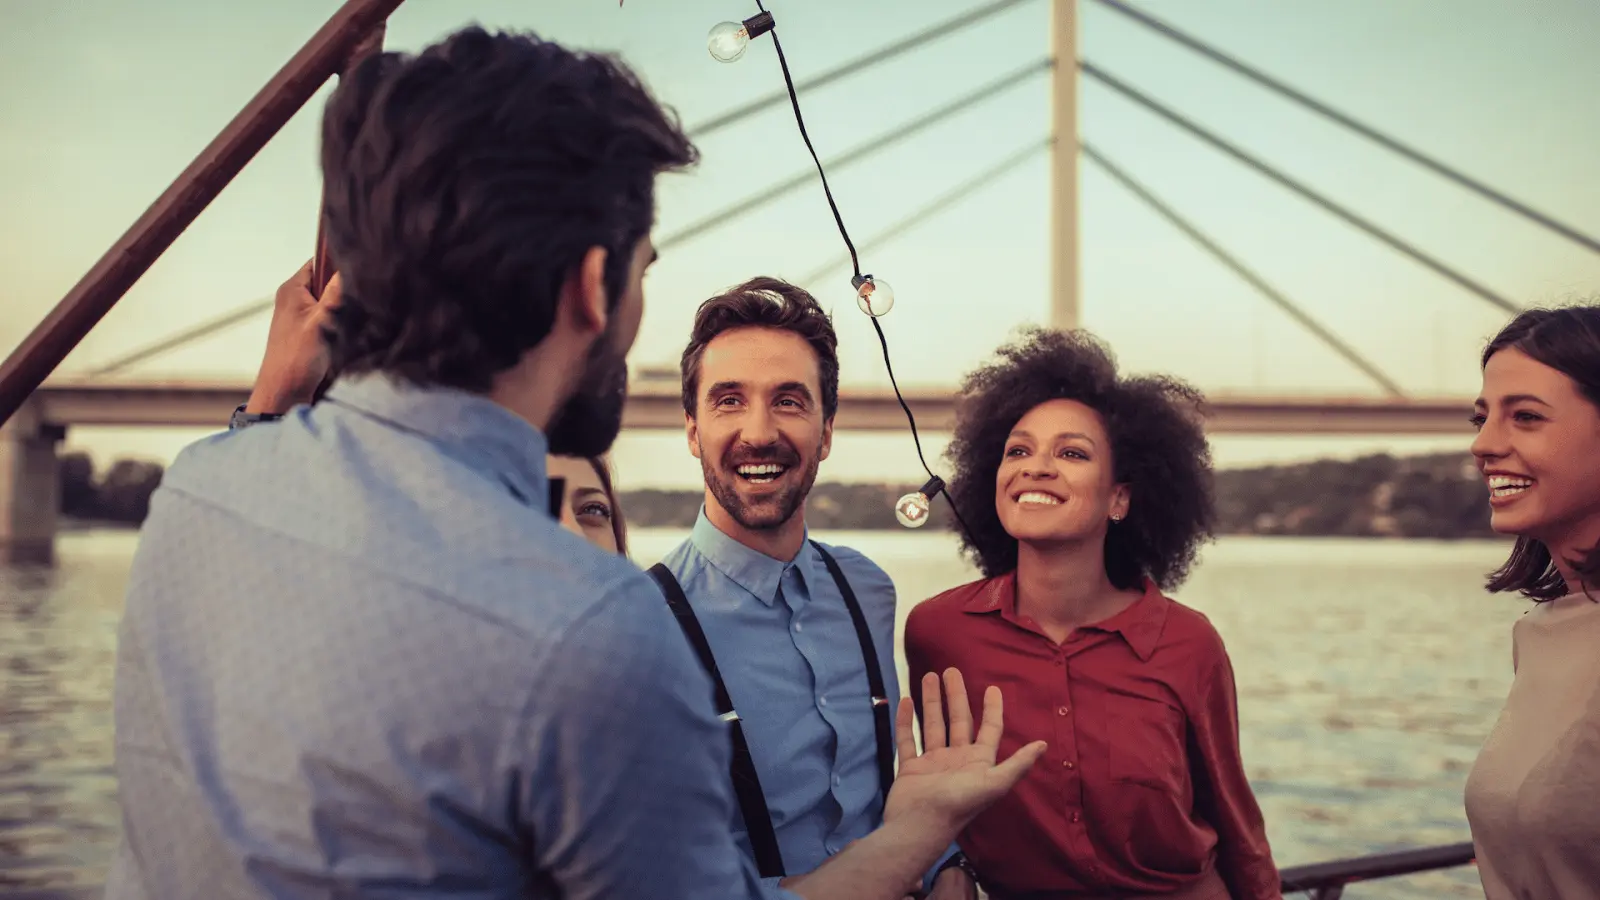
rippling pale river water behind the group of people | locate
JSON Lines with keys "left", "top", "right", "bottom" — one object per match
{"left": 0, "top": 530, "right": 1525, "bottom": 900}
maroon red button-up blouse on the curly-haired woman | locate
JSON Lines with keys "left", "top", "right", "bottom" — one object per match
{"left": 906, "top": 573, "right": 1282, "bottom": 900}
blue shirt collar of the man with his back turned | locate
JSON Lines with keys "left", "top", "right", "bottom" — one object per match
{"left": 326, "top": 373, "right": 549, "bottom": 511}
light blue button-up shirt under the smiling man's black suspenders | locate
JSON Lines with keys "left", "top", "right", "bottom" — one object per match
{"left": 662, "top": 508, "right": 955, "bottom": 897}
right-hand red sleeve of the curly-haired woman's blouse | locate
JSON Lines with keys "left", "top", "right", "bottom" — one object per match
{"left": 1190, "top": 637, "right": 1283, "bottom": 900}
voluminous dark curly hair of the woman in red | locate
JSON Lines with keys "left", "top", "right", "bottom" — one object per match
{"left": 946, "top": 328, "right": 1216, "bottom": 589}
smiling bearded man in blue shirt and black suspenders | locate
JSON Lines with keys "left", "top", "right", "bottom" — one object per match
{"left": 651, "top": 277, "right": 976, "bottom": 900}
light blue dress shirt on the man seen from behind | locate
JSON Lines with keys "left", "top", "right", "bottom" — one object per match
{"left": 106, "top": 376, "right": 777, "bottom": 900}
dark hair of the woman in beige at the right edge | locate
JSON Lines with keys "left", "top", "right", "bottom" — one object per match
{"left": 1483, "top": 304, "right": 1600, "bottom": 602}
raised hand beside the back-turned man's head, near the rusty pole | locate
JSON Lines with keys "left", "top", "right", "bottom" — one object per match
{"left": 245, "top": 263, "right": 341, "bottom": 413}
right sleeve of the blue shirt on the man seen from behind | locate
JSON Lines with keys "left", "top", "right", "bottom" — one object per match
{"left": 509, "top": 575, "right": 797, "bottom": 900}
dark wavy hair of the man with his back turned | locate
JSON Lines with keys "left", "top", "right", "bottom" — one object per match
{"left": 322, "top": 27, "right": 696, "bottom": 392}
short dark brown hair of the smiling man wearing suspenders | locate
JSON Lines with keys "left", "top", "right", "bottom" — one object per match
{"left": 680, "top": 275, "right": 838, "bottom": 421}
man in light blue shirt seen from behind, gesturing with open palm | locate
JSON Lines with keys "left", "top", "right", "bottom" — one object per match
{"left": 106, "top": 29, "right": 1038, "bottom": 900}
